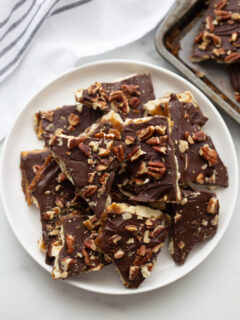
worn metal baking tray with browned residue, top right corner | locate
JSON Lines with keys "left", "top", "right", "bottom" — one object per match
{"left": 155, "top": 0, "right": 240, "bottom": 124}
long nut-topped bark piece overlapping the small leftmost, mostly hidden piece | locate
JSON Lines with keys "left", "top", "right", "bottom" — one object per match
{"left": 30, "top": 155, "right": 87, "bottom": 264}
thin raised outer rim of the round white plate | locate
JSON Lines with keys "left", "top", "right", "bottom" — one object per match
{"left": 0, "top": 59, "right": 239, "bottom": 295}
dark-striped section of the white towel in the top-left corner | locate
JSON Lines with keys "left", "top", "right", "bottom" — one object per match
{"left": 0, "top": 0, "right": 91, "bottom": 81}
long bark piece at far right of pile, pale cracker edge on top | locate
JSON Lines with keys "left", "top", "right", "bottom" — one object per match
{"left": 145, "top": 94, "right": 228, "bottom": 187}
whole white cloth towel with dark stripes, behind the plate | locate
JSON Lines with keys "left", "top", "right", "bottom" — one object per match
{"left": 0, "top": 0, "right": 174, "bottom": 141}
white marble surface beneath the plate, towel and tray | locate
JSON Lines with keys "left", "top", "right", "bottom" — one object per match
{"left": 0, "top": 31, "right": 240, "bottom": 320}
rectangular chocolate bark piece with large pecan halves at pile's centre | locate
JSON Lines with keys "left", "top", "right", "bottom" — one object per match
{"left": 122, "top": 116, "right": 181, "bottom": 202}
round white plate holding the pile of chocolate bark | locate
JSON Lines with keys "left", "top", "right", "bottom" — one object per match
{"left": 0, "top": 60, "right": 238, "bottom": 294}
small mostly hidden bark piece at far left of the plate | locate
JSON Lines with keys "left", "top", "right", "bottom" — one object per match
{"left": 20, "top": 150, "right": 49, "bottom": 206}
